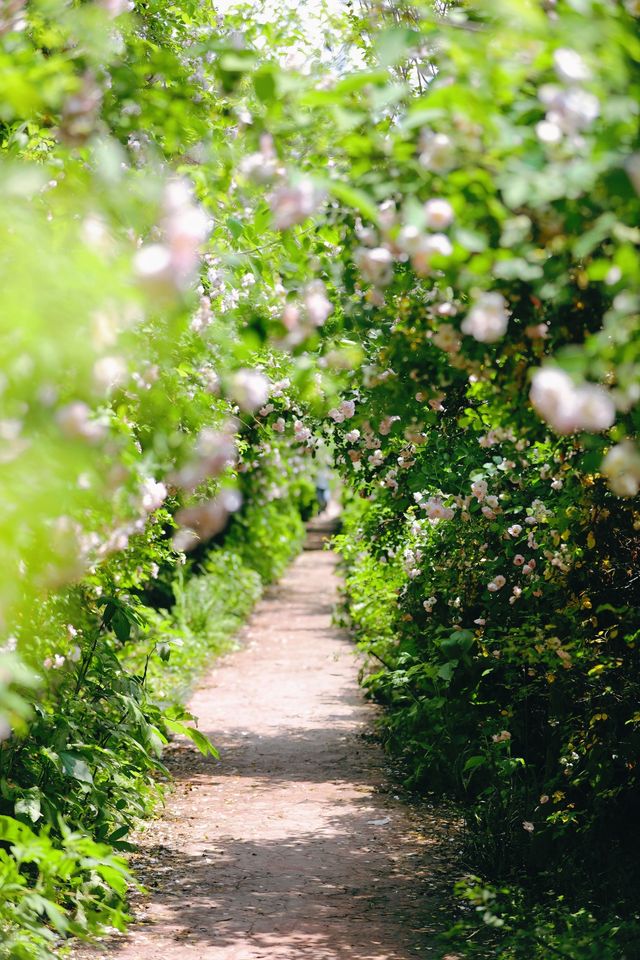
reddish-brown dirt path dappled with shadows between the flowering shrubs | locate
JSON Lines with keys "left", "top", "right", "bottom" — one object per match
{"left": 81, "top": 531, "right": 455, "bottom": 960}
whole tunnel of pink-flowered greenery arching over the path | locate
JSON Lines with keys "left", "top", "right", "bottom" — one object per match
{"left": 0, "top": 0, "right": 640, "bottom": 960}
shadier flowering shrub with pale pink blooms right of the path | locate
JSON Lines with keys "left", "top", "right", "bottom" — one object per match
{"left": 316, "top": 2, "right": 640, "bottom": 944}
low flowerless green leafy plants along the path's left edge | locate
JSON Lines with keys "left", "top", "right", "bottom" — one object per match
{"left": 0, "top": 480, "right": 310, "bottom": 960}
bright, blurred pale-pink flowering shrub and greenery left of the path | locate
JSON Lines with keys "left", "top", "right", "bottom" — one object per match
{"left": 0, "top": 0, "right": 324, "bottom": 960}
